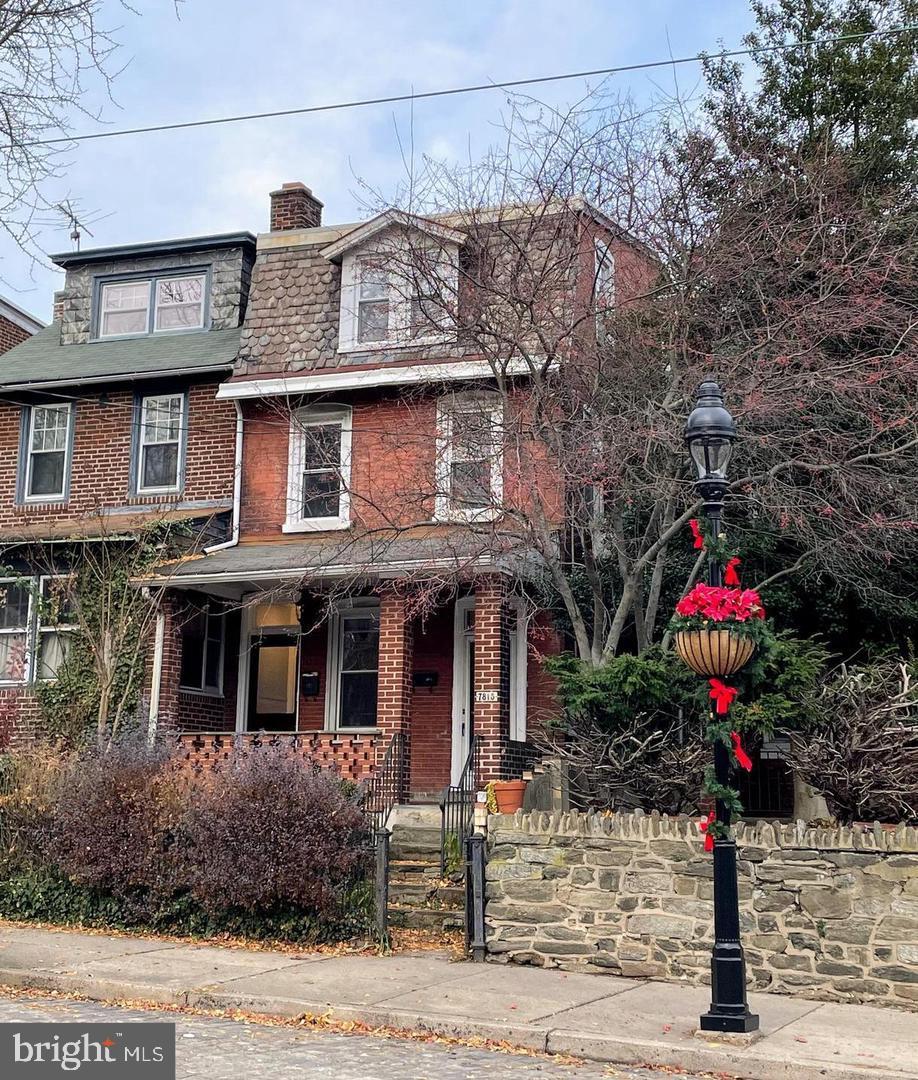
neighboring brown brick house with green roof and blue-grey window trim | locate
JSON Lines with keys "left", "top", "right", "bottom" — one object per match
{"left": 0, "top": 233, "right": 255, "bottom": 742}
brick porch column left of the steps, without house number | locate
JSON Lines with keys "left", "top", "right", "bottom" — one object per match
{"left": 376, "top": 588, "right": 414, "bottom": 793}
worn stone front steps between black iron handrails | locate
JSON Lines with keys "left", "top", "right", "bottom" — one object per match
{"left": 389, "top": 805, "right": 465, "bottom": 932}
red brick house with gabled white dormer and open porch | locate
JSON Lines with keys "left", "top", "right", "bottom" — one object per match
{"left": 141, "top": 184, "right": 633, "bottom": 800}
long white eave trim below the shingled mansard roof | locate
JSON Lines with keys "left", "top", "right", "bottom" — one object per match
{"left": 217, "top": 356, "right": 540, "bottom": 401}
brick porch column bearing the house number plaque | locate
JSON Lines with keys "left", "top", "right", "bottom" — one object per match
{"left": 472, "top": 576, "right": 510, "bottom": 784}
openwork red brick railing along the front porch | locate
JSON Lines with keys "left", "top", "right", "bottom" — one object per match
{"left": 178, "top": 731, "right": 381, "bottom": 780}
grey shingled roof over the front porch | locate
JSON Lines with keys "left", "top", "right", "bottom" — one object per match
{"left": 145, "top": 534, "right": 533, "bottom": 595}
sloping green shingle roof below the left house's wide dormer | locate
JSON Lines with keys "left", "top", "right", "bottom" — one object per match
{"left": 0, "top": 322, "right": 240, "bottom": 391}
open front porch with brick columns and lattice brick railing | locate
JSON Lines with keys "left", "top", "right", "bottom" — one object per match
{"left": 150, "top": 573, "right": 557, "bottom": 801}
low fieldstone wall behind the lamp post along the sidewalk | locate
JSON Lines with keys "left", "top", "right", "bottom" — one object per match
{"left": 486, "top": 811, "right": 918, "bottom": 1009}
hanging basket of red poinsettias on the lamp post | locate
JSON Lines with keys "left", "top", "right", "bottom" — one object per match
{"left": 670, "top": 584, "right": 768, "bottom": 678}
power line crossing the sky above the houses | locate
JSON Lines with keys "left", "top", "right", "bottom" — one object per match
{"left": 17, "top": 25, "right": 918, "bottom": 147}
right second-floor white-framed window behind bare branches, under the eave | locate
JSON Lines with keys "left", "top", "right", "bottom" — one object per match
{"left": 435, "top": 394, "right": 503, "bottom": 521}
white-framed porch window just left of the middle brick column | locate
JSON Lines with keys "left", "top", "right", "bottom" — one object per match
{"left": 325, "top": 600, "right": 379, "bottom": 731}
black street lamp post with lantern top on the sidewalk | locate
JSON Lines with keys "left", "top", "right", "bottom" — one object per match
{"left": 685, "top": 379, "right": 758, "bottom": 1031}
